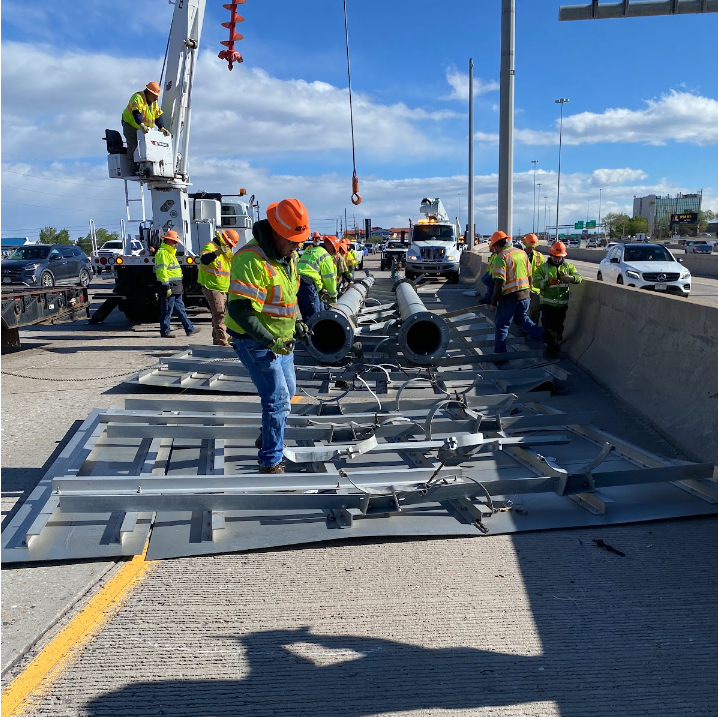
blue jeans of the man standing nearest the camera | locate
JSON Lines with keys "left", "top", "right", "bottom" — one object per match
{"left": 231, "top": 338, "right": 297, "bottom": 467}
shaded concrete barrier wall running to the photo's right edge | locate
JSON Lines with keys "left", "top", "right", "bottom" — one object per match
{"left": 562, "top": 279, "right": 718, "bottom": 463}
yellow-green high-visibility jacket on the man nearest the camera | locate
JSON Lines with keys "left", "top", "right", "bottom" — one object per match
{"left": 224, "top": 239, "right": 299, "bottom": 341}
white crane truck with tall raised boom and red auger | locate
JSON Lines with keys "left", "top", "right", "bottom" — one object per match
{"left": 97, "top": 0, "right": 258, "bottom": 323}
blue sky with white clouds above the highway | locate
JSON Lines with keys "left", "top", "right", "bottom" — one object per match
{"left": 2, "top": 0, "right": 718, "bottom": 241}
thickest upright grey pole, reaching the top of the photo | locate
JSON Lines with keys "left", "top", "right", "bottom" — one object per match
{"left": 497, "top": 0, "right": 516, "bottom": 236}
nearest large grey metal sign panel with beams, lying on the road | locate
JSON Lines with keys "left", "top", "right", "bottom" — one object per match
{"left": 2, "top": 394, "right": 718, "bottom": 563}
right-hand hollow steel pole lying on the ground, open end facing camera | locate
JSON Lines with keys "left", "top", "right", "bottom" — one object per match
{"left": 394, "top": 279, "right": 451, "bottom": 366}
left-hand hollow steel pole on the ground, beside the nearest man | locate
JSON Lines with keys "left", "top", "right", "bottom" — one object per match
{"left": 306, "top": 276, "right": 374, "bottom": 363}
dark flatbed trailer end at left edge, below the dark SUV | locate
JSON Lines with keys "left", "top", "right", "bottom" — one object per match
{"left": 2, "top": 286, "right": 90, "bottom": 347}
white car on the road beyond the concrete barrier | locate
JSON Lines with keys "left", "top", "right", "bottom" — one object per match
{"left": 596, "top": 243, "right": 691, "bottom": 296}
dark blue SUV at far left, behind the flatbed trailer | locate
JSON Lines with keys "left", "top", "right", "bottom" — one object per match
{"left": 2, "top": 244, "right": 92, "bottom": 287}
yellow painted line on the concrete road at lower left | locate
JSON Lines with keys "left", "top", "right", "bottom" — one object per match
{"left": 2, "top": 548, "right": 154, "bottom": 717}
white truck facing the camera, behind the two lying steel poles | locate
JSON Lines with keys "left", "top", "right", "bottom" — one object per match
{"left": 406, "top": 197, "right": 461, "bottom": 284}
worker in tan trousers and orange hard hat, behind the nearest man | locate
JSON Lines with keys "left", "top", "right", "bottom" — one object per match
{"left": 197, "top": 229, "right": 239, "bottom": 346}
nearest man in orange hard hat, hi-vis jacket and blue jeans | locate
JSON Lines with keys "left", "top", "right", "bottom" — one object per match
{"left": 225, "top": 199, "right": 309, "bottom": 473}
